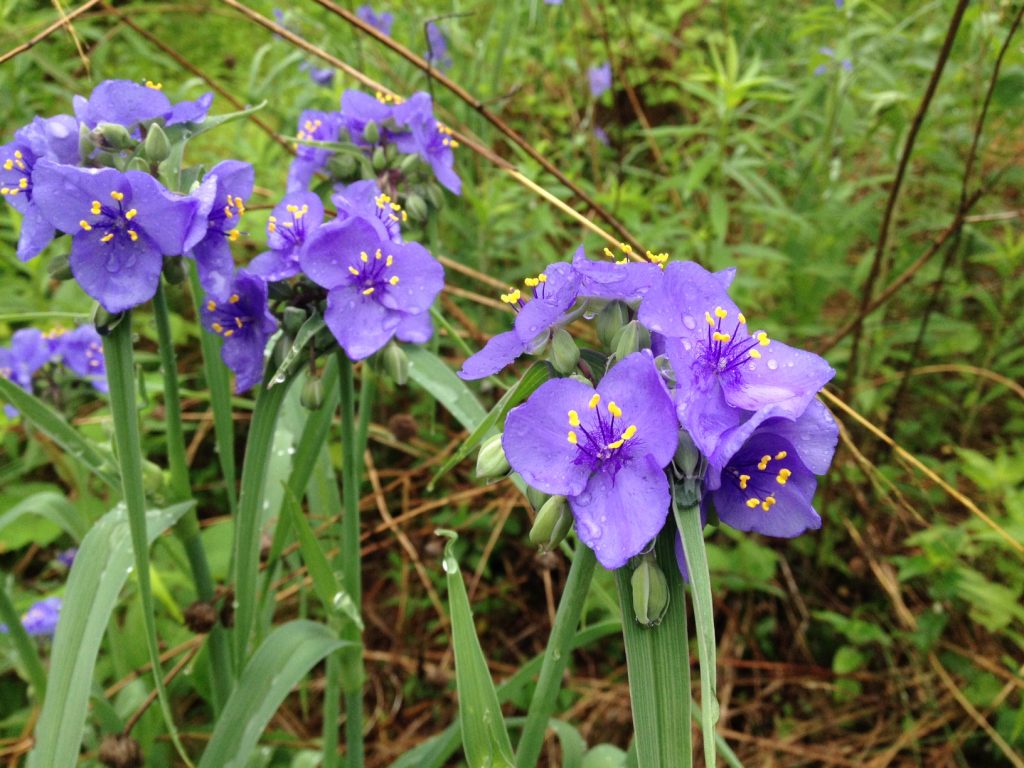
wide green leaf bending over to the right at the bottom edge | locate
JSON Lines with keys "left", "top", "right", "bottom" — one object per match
{"left": 199, "top": 620, "right": 345, "bottom": 768}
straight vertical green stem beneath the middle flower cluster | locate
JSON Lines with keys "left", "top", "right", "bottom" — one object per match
{"left": 337, "top": 349, "right": 369, "bottom": 768}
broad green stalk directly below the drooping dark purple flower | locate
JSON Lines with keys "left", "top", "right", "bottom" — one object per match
{"left": 233, "top": 373, "right": 295, "bottom": 670}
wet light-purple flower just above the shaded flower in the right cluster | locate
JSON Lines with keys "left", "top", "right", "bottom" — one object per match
{"left": 639, "top": 262, "right": 836, "bottom": 461}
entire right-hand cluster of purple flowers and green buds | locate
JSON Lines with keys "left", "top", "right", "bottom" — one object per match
{"left": 468, "top": 246, "right": 838, "bottom": 589}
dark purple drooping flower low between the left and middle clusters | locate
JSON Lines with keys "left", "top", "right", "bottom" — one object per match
{"left": 203, "top": 269, "right": 278, "bottom": 392}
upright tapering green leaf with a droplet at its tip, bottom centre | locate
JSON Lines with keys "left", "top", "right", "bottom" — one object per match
{"left": 437, "top": 530, "right": 515, "bottom": 768}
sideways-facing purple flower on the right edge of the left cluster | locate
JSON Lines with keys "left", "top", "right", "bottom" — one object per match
{"left": 191, "top": 160, "right": 255, "bottom": 295}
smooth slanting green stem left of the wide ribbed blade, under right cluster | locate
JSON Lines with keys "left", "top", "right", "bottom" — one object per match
{"left": 515, "top": 542, "right": 597, "bottom": 768}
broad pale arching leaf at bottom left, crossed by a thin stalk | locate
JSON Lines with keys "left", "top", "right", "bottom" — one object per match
{"left": 28, "top": 502, "right": 194, "bottom": 768}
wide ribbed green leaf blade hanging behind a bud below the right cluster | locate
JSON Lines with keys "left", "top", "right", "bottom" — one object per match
{"left": 615, "top": 525, "right": 693, "bottom": 768}
